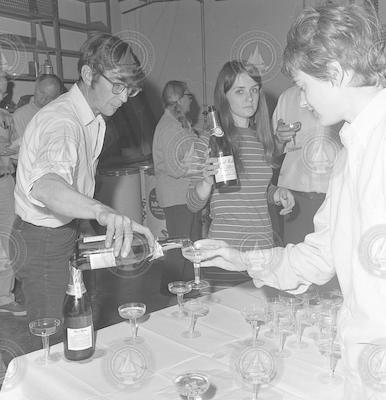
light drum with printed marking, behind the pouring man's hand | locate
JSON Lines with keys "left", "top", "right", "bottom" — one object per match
{"left": 139, "top": 164, "right": 168, "bottom": 238}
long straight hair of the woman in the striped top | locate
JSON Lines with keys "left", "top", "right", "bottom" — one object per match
{"left": 214, "top": 60, "right": 275, "bottom": 171}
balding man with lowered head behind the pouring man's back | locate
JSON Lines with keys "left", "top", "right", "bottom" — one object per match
{"left": 13, "top": 74, "right": 63, "bottom": 145}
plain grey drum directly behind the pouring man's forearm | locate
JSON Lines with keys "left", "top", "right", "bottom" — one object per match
{"left": 94, "top": 167, "right": 142, "bottom": 224}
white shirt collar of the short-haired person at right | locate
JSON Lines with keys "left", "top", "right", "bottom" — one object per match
{"left": 340, "top": 89, "right": 386, "bottom": 147}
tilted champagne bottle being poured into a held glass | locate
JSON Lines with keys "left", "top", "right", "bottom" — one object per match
{"left": 75, "top": 232, "right": 188, "bottom": 270}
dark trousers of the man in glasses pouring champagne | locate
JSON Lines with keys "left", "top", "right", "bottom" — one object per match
{"left": 9, "top": 216, "right": 78, "bottom": 328}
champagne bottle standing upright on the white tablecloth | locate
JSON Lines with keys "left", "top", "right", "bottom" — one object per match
{"left": 63, "top": 256, "right": 95, "bottom": 361}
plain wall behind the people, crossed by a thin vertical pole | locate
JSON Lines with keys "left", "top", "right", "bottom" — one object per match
{"left": 120, "top": 0, "right": 303, "bottom": 118}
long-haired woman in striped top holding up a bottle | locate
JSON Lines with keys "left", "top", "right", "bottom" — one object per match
{"left": 187, "top": 60, "right": 294, "bottom": 288}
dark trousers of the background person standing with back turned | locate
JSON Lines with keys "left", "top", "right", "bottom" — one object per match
{"left": 160, "top": 204, "right": 201, "bottom": 295}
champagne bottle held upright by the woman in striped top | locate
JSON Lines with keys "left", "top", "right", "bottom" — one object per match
{"left": 208, "top": 106, "right": 237, "bottom": 188}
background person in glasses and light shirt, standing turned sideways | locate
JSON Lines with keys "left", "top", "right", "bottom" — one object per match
{"left": 153, "top": 81, "right": 201, "bottom": 295}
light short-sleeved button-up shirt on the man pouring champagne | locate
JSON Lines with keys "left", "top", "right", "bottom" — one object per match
{"left": 15, "top": 84, "right": 106, "bottom": 228}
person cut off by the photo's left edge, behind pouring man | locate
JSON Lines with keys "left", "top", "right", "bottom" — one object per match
{"left": 0, "top": 73, "right": 27, "bottom": 317}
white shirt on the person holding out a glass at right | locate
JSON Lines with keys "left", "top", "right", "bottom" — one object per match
{"left": 249, "top": 89, "right": 386, "bottom": 400}
